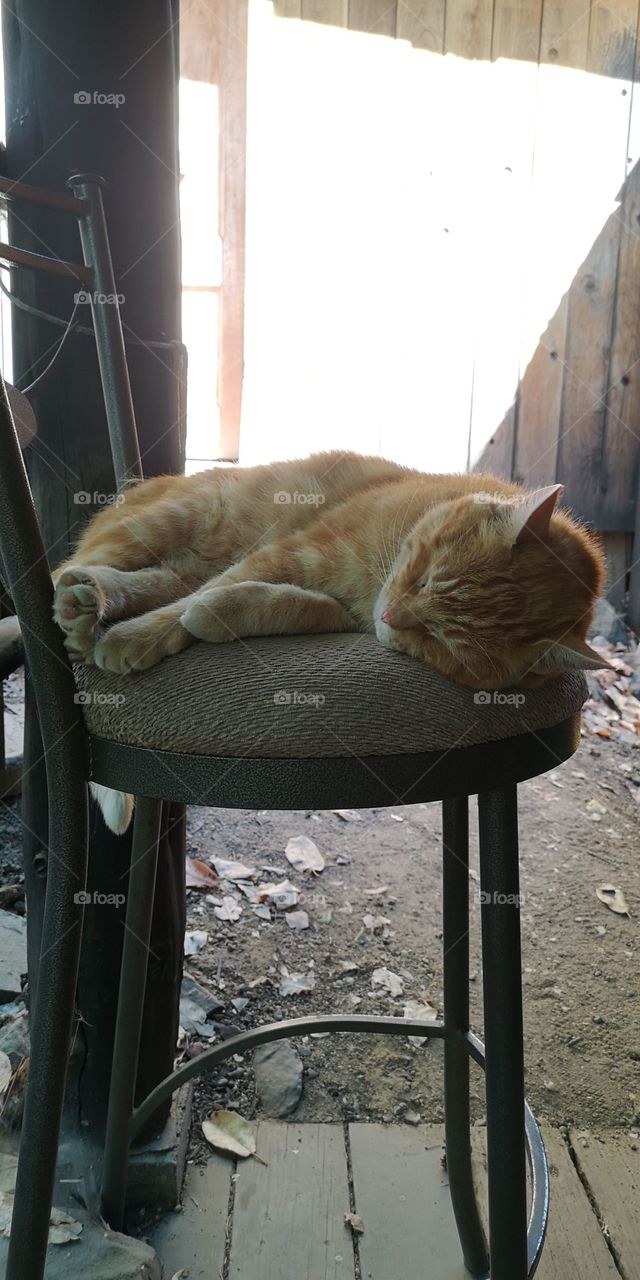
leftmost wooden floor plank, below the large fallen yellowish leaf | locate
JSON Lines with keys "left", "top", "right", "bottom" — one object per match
{"left": 151, "top": 1156, "right": 234, "bottom": 1280}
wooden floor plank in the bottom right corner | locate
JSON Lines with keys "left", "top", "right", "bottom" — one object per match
{"left": 571, "top": 1133, "right": 640, "bottom": 1280}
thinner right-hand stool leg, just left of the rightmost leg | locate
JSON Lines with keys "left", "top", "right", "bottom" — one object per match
{"left": 443, "top": 796, "right": 489, "bottom": 1276}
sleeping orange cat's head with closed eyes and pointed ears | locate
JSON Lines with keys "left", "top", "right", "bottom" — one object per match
{"left": 374, "top": 485, "right": 607, "bottom": 689}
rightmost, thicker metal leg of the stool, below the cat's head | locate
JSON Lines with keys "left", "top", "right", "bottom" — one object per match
{"left": 477, "top": 786, "right": 527, "bottom": 1280}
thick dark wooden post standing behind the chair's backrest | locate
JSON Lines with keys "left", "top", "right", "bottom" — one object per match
{"left": 3, "top": 0, "right": 184, "bottom": 1139}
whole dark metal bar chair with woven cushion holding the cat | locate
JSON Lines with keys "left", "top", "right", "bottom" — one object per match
{"left": 0, "top": 172, "right": 586, "bottom": 1280}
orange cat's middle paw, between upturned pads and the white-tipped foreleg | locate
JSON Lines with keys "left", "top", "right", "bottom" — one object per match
{"left": 93, "top": 609, "right": 192, "bottom": 676}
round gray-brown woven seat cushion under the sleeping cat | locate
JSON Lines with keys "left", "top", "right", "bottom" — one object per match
{"left": 76, "top": 635, "right": 586, "bottom": 756}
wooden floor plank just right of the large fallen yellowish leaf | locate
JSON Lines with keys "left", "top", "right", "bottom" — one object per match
{"left": 229, "top": 1121, "right": 355, "bottom": 1280}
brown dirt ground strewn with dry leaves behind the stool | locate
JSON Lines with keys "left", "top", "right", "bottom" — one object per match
{"left": 0, "top": 670, "right": 640, "bottom": 1155}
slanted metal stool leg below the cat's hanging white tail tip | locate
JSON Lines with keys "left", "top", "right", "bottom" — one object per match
{"left": 102, "top": 797, "right": 163, "bottom": 1231}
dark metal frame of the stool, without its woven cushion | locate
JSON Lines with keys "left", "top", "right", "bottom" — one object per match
{"left": 0, "top": 178, "right": 570, "bottom": 1280}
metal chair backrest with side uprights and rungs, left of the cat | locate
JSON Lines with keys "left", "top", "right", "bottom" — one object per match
{"left": 0, "top": 174, "right": 142, "bottom": 769}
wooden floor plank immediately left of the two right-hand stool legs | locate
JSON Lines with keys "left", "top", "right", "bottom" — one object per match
{"left": 349, "top": 1124, "right": 468, "bottom": 1280}
